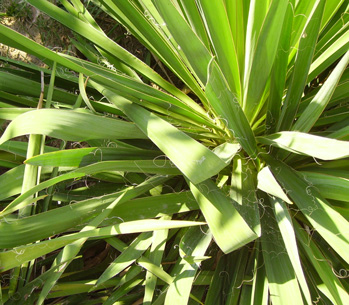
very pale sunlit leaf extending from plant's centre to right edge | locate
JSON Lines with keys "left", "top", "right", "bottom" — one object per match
{"left": 258, "top": 131, "right": 349, "bottom": 160}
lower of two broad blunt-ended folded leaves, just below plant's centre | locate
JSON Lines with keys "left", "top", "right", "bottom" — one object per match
{"left": 190, "top": 180, "right": 258, "bottom": 253}
